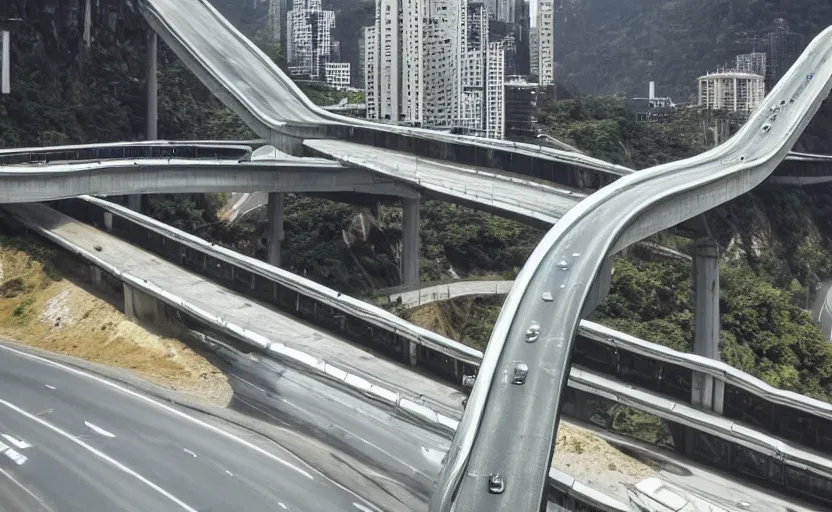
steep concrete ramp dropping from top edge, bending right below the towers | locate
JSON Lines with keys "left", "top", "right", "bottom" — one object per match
{"left": 139, "top": 0, "right": 632, "bottom": 180}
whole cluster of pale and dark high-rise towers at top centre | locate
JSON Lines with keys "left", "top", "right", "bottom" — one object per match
{"left": 361, "top": 0, "right": 555, "bottom": 139}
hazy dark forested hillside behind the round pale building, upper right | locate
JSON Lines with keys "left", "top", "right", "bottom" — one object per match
{"left": 555, "top": 0, "right": 832, "bottom": 101}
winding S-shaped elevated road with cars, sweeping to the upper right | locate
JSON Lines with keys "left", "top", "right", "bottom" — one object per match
{"left": 446, "top": 26, "right": 832, "bottom": 512}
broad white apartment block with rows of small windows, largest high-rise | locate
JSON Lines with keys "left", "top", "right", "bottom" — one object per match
{"left": 363, "top": 0, "right": 504, "bottom": 137}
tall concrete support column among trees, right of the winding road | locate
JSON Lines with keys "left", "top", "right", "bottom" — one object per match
{"left": 691, "top": 238, "right": 725, "bottom": 414}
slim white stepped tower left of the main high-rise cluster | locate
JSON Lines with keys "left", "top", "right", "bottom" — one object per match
{"left": 286, "top": 0, "right": 335, "bottom": 80}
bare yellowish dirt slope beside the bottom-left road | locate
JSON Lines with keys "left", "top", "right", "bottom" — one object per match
{"left": 0, "top": 237, "right": 232, "bottom": 405}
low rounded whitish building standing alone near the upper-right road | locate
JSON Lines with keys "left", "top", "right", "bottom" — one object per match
{"left": 699, "top": 71, "right": 766, "bottom": 113}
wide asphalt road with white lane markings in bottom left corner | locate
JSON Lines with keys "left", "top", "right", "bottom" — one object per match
{"left": 0, "top": 346, "right": 386, "bottom": 512}
